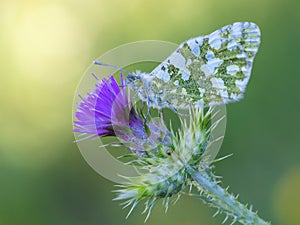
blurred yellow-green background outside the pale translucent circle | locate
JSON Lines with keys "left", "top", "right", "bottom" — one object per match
{"left": 0, "top": 0, "right": 300, "bottom": 225}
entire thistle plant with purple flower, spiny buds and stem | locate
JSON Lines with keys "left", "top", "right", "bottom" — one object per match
{"left": 74, "top": 74, "right": 270, "bottom": 225}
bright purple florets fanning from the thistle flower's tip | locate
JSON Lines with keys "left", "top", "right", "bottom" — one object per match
{"left": 73, "top": 74, "right": 129, "bottom": 137}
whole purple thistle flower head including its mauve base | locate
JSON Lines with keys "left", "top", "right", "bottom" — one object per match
{"left": 73, "top": 74, "right": 169, "bottom": 155}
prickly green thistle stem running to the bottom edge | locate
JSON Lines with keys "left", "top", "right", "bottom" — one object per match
{"left": 186, "top": 165, "right": 270, "bottom": 225}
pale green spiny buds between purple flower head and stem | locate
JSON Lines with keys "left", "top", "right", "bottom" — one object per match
{"left": 115, "top": 109, "right": 216, "bottom": 219}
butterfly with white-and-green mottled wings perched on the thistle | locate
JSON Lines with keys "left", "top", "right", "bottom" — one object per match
{"left": 96, "top": 22, "right": 260, "bottom": 110}
